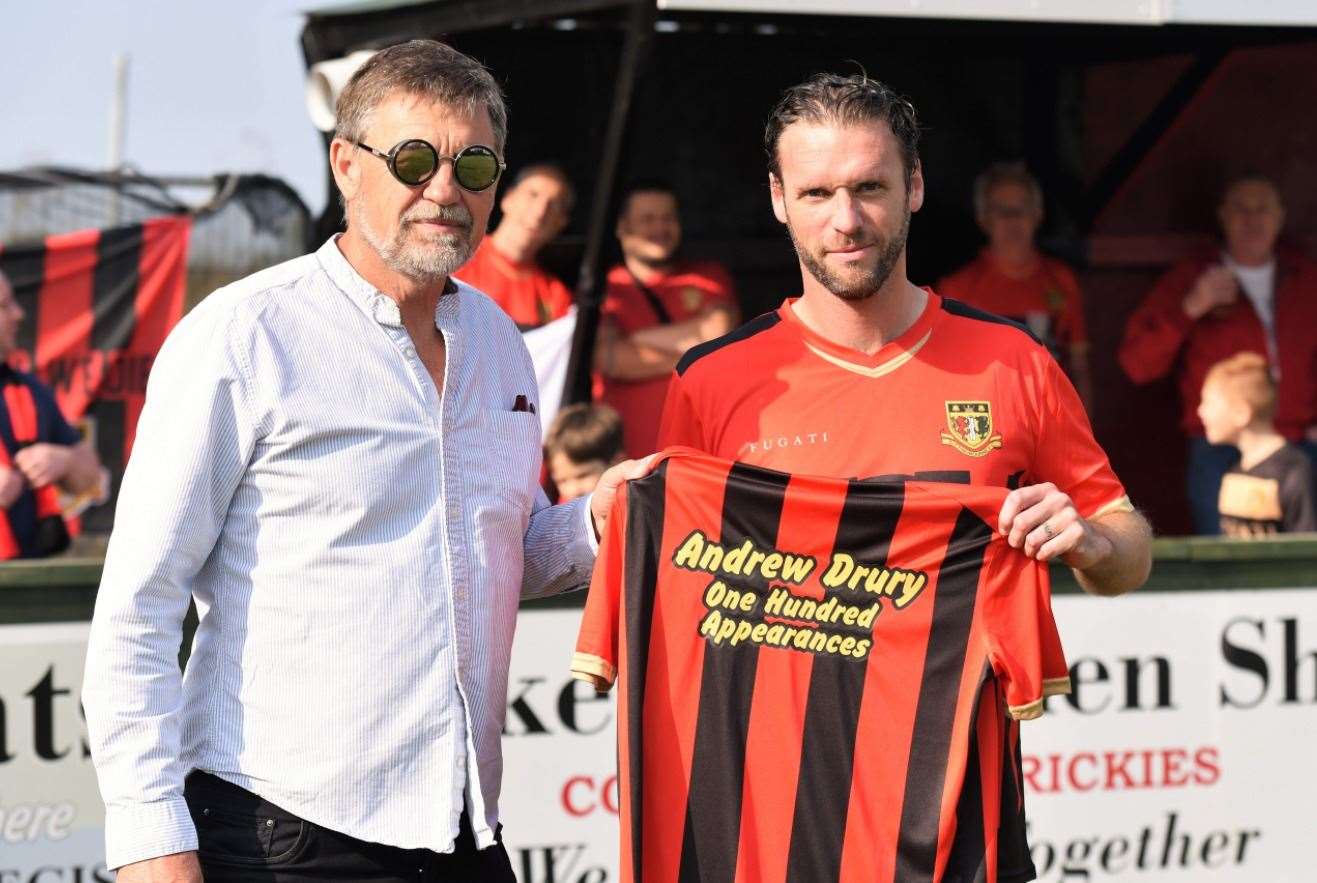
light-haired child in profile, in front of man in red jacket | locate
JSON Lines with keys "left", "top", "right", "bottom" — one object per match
{"left": 1198, "top": 353, "right": 1317, "bottom": 536}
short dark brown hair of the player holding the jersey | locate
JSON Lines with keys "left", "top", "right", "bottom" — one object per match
{"left": 764, "top": 74, "right": 919, "bottom": 185}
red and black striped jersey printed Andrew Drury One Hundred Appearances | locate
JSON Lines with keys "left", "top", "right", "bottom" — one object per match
{"left": 573, "top": 449, "right": 1069, "bottom": 883}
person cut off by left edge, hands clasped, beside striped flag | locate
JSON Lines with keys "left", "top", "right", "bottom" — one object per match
{"left": 0, "top": 273, "right": 105, "bottom": 560}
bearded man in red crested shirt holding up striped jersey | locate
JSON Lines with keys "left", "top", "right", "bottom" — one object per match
{"left": 659, "top": 75, "right": 1151, "bottom": 880}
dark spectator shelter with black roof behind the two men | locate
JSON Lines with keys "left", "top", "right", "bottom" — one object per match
{"left": 303, "top": 0, "right": 1317, "bottom": 534}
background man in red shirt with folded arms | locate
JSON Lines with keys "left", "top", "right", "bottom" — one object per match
{"left": 595, "top": 181, "right": 740, "bottom": 457}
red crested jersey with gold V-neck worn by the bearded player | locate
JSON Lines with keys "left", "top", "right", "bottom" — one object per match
{"left": 659, "top": 290, "right": 1133, "bottom": 882}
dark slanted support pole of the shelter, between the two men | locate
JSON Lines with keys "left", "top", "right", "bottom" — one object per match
{"left": 562, "top": 0, "right": 659, "bottom": 405}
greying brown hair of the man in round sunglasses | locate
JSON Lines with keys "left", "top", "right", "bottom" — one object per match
{"left": 333, "top": 40, "right": 507, "bottom": 153}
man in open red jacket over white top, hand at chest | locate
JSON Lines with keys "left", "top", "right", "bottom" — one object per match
{"left": 1119, "top": 174, "right": 1317, "bottom": 534}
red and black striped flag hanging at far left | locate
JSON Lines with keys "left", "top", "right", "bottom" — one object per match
{"left": 0, "top": 215, "right": 191, "bottom": 528}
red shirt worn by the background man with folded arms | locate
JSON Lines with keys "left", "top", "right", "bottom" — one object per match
{"left": 595, "top": 262, "right": 736, "bottom": 457}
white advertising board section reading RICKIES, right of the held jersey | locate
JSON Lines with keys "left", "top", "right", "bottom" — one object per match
{"left": 1021, "top": 589, "right": 1317, "bottom": 883}
